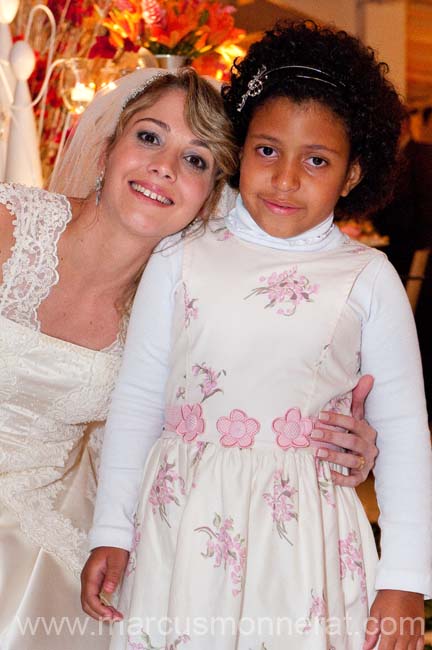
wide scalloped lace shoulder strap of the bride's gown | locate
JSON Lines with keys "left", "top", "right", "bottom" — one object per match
{"left": 0, "top": 184, "right": 72, "bottom": 331}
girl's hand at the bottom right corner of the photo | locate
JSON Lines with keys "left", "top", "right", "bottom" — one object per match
{"left": 363, "top": 589, "right": 424, "bottom": 650}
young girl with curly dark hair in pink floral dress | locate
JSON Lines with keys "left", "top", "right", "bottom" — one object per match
{"left": 83, "top": 24, "right": 432, "bottom": 650}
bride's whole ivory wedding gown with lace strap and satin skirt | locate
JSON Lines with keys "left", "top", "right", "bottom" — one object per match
{"left": 0, "top": 185, "right": 121, "bottom": 650}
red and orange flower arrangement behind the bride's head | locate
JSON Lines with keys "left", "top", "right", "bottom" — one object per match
{"left": 12, "top": 0, "right": 244, "bottom": 178}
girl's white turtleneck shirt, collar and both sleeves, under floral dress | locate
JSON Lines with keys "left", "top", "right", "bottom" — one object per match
{"left": 90, "top": 198, "right": 432, "bottom": 597}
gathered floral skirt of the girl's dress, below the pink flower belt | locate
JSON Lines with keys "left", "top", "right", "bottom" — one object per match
{"left": 110, "top": 435, "right": 377, "bottom": 650}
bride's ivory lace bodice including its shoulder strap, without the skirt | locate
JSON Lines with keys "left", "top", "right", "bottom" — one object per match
{"left": 0, "top": 185, "right": 124, "bottom": 572}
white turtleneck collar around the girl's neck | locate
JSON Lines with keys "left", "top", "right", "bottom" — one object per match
{"left": 225, "top": 195, "right": 340, "bottom": 251}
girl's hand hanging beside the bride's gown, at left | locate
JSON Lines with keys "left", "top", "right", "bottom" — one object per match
{"left": 81, "top": 546, "right": 129, "bottom": 621}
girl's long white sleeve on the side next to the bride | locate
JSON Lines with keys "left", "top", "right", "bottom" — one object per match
{"left": 89, "top": 243, "right": 182, "bottom": 550}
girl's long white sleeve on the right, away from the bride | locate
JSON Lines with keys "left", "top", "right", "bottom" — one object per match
{"left": 350, "top": 253, "right": 432, "bottom": 597}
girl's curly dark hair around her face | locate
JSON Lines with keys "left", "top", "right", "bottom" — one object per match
{"left": 222, "top": 21, "right": 406, "bottom": 216}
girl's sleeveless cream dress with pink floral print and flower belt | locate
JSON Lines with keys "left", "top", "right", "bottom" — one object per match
{"left": 111, "top": 221, "right": 381, "bottom": 650}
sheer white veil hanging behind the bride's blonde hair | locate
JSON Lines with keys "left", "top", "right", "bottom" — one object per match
{"left": 48, "top": 68, "right": 166, "bottom": 198}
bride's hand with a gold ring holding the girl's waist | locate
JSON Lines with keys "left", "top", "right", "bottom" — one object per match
{"left": 311, "top": 375, "right": 378, "bottom": 487}
